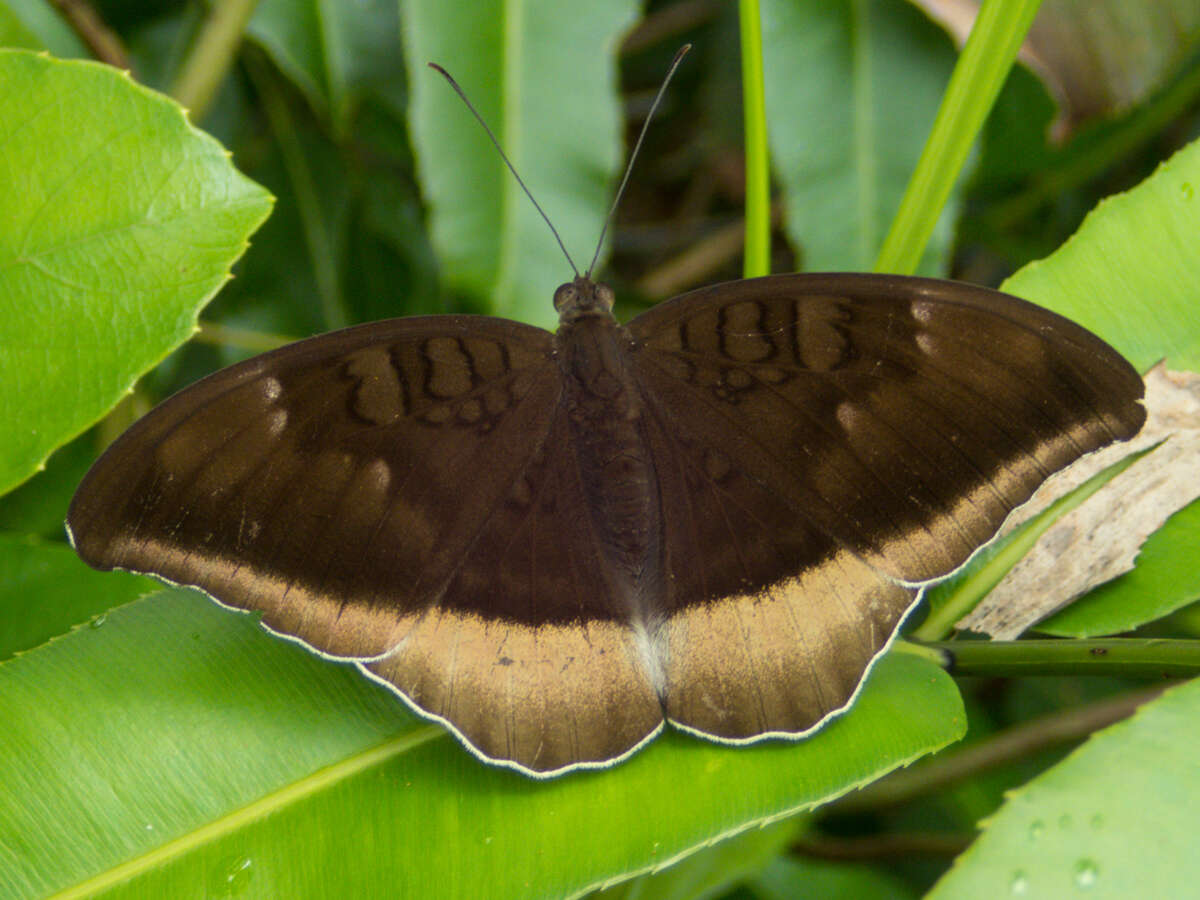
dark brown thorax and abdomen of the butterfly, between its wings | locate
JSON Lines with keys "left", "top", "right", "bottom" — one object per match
{"left": 556, "top": 304, "right": 658, "bottom": 600}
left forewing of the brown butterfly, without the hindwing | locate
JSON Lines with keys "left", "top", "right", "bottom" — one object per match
{"left": 68, "top": 317, "right": 557, "bottom": 658}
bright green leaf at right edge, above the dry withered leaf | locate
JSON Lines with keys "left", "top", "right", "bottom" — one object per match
{"left": 1001, "top": 131, "right": 1200, "bottom": 372}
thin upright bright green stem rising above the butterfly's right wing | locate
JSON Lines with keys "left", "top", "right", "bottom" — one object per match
{"left": 738, "top": 0, "right": 770, "bottom": 278}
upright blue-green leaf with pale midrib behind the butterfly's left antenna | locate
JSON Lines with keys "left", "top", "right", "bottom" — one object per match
{"left": 402, "top": 0, "right": 637, "bottom": 328}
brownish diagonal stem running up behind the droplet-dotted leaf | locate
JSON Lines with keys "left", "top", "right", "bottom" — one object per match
{"left": 826, "top": 681, "right": 1164, "bottom": 814}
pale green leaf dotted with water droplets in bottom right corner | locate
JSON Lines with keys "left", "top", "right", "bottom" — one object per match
{"left": 930, "top": 680, "right": 1200, "bottom": 900}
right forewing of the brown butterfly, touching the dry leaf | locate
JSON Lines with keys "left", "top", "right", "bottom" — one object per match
{"left": 629, "top": 275, "right": 1145, "bottom": 583}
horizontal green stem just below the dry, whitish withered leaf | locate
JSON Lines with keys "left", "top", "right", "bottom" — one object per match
{"left": 926, "top": 637, "right": 1200, "bottom": 678}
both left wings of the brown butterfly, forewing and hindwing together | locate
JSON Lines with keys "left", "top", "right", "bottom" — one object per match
{"left": 68, "top": 317, "right": 662, "bottom": 774}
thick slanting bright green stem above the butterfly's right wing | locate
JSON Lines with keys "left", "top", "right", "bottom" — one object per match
{"left": 875, "top": 0, "right": 1040, "bottom": 275}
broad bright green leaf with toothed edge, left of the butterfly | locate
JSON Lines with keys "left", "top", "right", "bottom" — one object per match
{"left": 0, "top": 50, "right": 270, "bottom": 493}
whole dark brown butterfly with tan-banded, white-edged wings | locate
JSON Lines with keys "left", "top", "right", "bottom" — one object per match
{"left": 67, "top": 266, "right": 1145, "bottom": 776}
